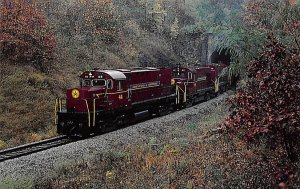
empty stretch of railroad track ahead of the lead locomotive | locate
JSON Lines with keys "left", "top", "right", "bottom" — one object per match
{"left": 0, "top": 136, "right": 74, "bottom": 162}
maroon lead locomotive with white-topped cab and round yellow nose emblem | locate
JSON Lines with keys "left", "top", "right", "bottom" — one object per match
{"left": 56, "top": 68, "right": 175, "bottom": 136}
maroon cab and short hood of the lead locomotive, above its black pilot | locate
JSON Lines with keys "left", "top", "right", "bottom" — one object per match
{"left": 67, "top": 70, "right": 128, "bottom": 112}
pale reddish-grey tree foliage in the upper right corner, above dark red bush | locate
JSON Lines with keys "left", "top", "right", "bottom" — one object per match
{"left": 243, "top": 0, "right": 300, "bottom": 49}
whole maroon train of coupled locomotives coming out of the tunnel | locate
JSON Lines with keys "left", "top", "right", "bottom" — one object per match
{"left": 55, "top": 65, "right": 227, "bottom": 137}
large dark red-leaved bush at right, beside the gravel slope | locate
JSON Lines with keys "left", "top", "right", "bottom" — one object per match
{"left": 225, "top": 37, "right": 300, "bottom": 160}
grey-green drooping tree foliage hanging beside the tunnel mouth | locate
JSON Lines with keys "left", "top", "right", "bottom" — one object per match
{"left": 197, "top": 0, "right": 265, "bottom": 78}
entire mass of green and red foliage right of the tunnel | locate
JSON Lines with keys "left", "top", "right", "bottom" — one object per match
{"left": 198, "top": 0, "right": 300, "bottom": 163}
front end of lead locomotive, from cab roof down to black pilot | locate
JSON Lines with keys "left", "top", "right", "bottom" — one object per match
{"left": 57, "top": 69, "right": 130, "bottom": 136}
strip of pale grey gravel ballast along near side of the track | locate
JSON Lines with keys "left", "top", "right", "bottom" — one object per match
{"left": 0, "top": 93, "right": 228, "bottom": 180}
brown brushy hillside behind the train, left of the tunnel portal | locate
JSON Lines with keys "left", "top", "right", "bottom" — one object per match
{"left": 0, "top": 1, "right": 198, "bottom": 149}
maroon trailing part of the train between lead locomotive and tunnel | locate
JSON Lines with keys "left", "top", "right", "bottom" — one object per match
{"left": 173, "top": 64, "right": 228, "bottom": 106}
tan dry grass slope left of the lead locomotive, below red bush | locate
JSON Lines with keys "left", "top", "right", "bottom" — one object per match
{"left": 0, "top": 65, "right": 64, "bottom": 148}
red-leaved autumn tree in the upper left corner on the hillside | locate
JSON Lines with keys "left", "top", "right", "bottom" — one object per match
{"left": 0, "top": 0, "right": 56, "bottom": 63}
